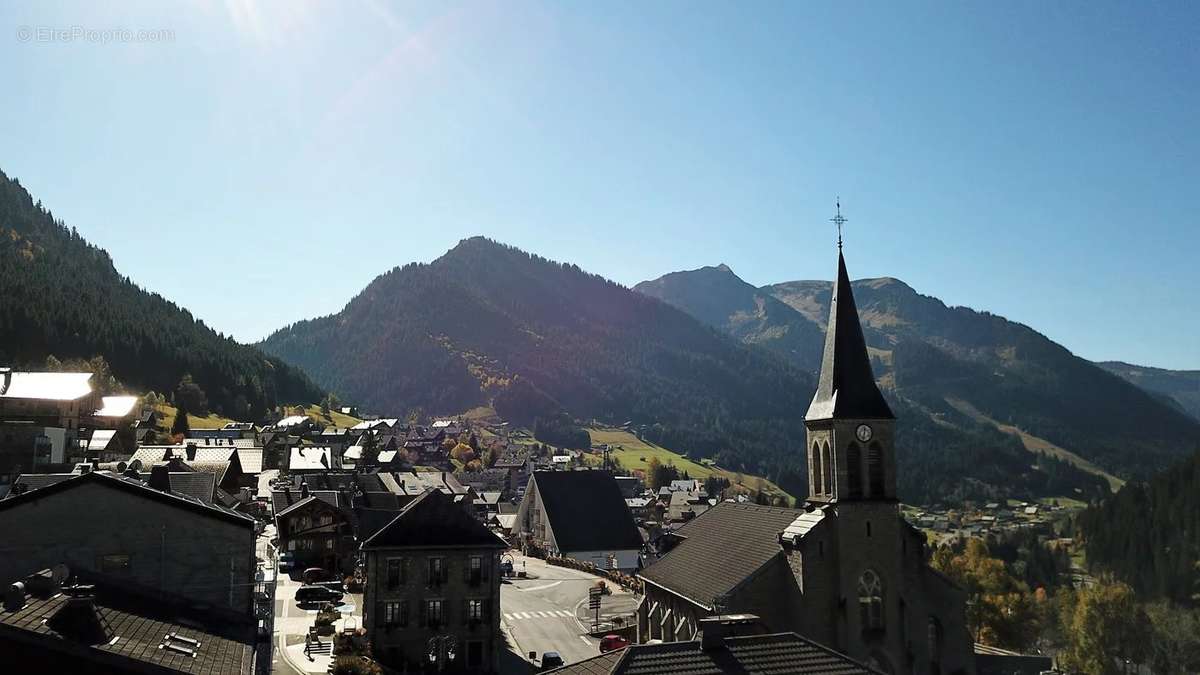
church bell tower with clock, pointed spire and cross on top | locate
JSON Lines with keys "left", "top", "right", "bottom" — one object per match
{"left": 804, "top": 203, "right": 896, "bottom": 503}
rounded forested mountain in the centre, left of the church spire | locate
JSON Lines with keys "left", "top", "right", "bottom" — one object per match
{"left": 263, "top": 238, "right": 814, "bottom": 489}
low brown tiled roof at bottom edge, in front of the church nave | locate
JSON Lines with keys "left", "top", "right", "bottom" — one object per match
{"left": 551, "top": 633, "right": 875, "bottom": 675}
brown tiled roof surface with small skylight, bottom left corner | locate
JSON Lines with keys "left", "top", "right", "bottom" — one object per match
{"left": 0, "top": 576, "right": 254, "bottom": 675}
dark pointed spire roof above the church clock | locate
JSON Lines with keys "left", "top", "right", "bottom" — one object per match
{"left": 804, "top": 251, "right": 895, "bottom": 419}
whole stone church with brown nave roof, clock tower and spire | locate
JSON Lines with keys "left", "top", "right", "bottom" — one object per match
{"left": 637, "top": 230, "right": 976, "bottom": 675}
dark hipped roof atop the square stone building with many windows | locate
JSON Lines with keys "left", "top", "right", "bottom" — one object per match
{"left": 362, "top": 490, "right": 508, "bottom": 549}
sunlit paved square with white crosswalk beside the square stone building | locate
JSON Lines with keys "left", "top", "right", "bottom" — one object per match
{"left": 500, "top": 555, "right": 638, "bottom": 663}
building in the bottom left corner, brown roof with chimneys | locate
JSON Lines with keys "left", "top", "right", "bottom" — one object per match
{"left": 0, "top": 566, "right": 254, "bottom": 675}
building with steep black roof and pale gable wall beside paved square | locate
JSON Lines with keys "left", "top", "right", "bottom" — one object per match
{"left": 512, "top": 471, "right": 642, "bottom": 571}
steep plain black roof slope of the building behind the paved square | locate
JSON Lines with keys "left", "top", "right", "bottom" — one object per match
{"left": 527, "top": 471, "right": 642, "bottom": 552}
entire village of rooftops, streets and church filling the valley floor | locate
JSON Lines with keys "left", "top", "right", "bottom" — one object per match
{"left": 0, "top": 246, "right": 1132, "bottom": 673}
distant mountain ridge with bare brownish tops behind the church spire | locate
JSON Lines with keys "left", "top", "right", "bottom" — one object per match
{"left": 636, "top": 258, "right": 1200, "bottom": 489}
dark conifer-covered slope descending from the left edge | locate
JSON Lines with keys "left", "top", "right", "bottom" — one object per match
{"left": 0, "top": 173, "right": 322, "bottom": 419}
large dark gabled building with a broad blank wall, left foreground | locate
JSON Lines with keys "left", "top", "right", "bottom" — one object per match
{"left": 0, "top": 471, "right": 256, "bottom": 617}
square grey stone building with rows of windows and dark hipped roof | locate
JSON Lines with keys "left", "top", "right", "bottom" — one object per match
{"left": 362, "top": 490, "right": 506, "bottom": 673}
